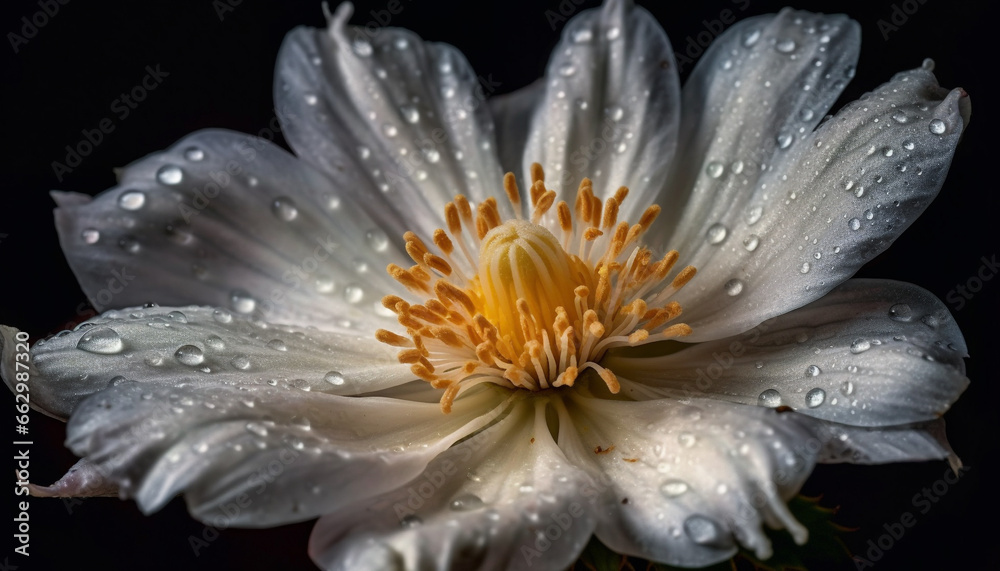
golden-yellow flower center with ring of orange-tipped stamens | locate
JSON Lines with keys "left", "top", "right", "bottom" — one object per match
{"left": 376, "top": 163, "right": 695, "bottom": 413}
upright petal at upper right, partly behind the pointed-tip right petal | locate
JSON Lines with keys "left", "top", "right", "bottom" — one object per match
{"left": 650, "top": 9, "right": 861, "bottom": 250}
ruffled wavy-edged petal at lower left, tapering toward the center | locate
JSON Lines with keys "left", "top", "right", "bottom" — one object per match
{"left": 67, "top": 381, "right": 504, "bottom": 527}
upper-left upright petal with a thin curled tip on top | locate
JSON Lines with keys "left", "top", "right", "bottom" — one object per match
{"left": 275, "top": 2, "right": 503, "bottom": 236}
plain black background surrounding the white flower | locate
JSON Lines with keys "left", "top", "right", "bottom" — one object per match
{"left": 0, "top": 0, "right": 1000, "bottom": 570}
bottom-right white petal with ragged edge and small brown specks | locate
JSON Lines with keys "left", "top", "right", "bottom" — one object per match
{"left": 559, "top": 393, "right": 821, "bottom": 567}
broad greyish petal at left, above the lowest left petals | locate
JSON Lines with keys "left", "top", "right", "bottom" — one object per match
{"left": 56, "top": 131, "right": 408, "bottom": 331}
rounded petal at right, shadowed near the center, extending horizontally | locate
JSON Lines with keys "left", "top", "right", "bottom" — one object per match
{"left": 605, "top": 280, "right": 969, "bottom": 426}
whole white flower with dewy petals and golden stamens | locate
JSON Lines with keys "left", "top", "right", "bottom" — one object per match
{"left": 3, "top": 0, "right": 969, "bottom": 569}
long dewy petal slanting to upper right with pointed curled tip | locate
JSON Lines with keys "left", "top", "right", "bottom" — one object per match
{"left": 671, "top": 64, "right": 968, "bottom": 341}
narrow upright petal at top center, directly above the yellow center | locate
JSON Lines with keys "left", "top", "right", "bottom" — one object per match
{"left": 523, "top": 0, "right": 680, "bottom": 219}
